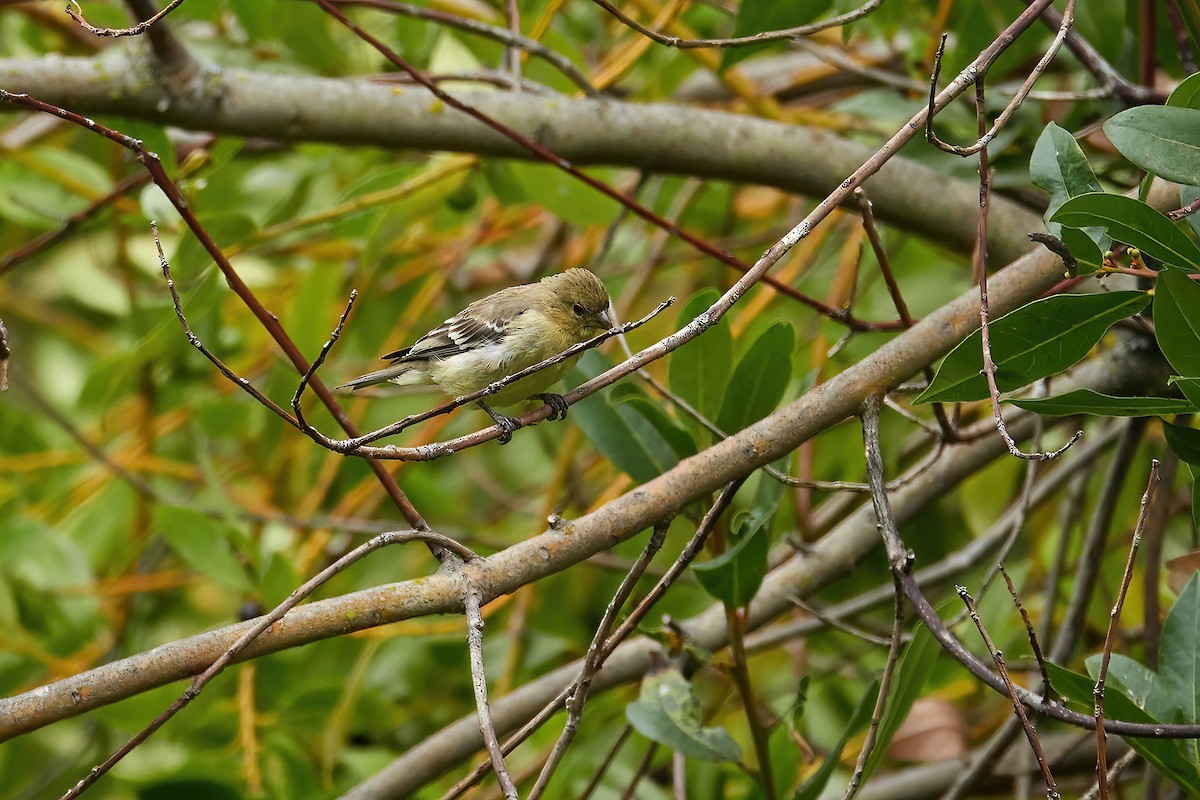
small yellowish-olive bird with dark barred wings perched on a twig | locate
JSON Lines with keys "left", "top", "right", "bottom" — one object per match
{"left": 338, "top": 269, "right": 612, "bottom": 444}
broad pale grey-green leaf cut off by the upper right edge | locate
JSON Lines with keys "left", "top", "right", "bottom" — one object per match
{"left": 1104, "top": 106, "right": 1200, "bottom": 185}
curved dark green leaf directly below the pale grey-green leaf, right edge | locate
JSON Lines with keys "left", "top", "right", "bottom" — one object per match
{"left": 1051, "top": 192, "right": 1200, "bottom": 270}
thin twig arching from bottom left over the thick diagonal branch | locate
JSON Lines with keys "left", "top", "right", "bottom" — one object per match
{"left": 60, "top": 530, "right": 476, "bottom": 800}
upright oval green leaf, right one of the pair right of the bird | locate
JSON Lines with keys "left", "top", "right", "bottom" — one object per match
{"left": 716, "top": 323, "right": 796, "bottom": 433}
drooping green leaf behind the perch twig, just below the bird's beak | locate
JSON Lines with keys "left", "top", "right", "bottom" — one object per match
{"left": 571, "top": 350, "right": 679, "bottom": 483}
